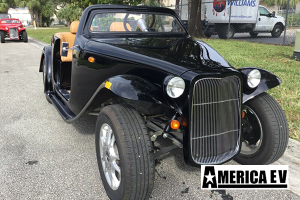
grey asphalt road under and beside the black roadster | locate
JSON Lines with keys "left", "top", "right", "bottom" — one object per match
{"left": 0, "top": 39, "right": 300, "bottom": 200}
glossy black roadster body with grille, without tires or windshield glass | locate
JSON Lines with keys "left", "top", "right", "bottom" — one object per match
{"left": 40, "top": 5, "right": 288, "bottom": 198}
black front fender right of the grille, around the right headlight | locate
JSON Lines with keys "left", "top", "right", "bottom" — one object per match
{"left": 238, "top": 67, "right": 281, "bottom": 103}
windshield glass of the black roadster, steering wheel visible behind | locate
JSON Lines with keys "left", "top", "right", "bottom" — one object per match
{"left": 90, "top": 13, "right": 185, "bottom": 33}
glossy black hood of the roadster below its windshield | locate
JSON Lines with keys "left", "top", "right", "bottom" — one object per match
{"left": 85, "top": 37, "right": 235, "bottom": 75}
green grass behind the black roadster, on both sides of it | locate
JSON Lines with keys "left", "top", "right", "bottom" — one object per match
{"left": 27, "top": 28, "right": 300, "bottom": 141}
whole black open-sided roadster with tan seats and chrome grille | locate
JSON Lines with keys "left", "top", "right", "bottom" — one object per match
{"left": 39, "top": 5, "right": 288, "bottom": 200}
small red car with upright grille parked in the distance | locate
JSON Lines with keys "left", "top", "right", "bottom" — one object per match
{"left": 0, "top": 18, "right": 28, "bottom": 43}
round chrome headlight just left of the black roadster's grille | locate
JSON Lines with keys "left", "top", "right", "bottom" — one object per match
{"left": 166, "top": 77, "right": 185, "bottom": 98}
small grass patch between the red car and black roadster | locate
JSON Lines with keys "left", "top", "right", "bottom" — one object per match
{"left": 26, "top": 27, "right": 70, "bottom": 44}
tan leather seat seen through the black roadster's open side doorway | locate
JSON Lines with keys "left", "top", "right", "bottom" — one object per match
{"left": 54, "top": 21, "right": 79, "bottom": 62}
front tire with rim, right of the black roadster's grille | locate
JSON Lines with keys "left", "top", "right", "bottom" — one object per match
{"left": 234, "top": 93, "right": 289, "bottom": 165}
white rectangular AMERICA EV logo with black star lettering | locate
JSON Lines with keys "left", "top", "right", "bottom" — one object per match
{"left": 201, "top": 165, "right": 288, "bottom": 189}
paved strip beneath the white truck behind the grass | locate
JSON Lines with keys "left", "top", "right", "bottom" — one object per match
{"left": 211, "top": 30, "right": 296, "bottom": 45}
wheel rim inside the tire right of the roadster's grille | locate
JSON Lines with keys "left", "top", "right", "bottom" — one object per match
{"left": 240, "top": 106, "right": 263, "bottom": 156}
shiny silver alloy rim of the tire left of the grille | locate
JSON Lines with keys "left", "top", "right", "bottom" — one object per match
{"left": 99, "top": 123, "right": 121, "bottom": 190}
